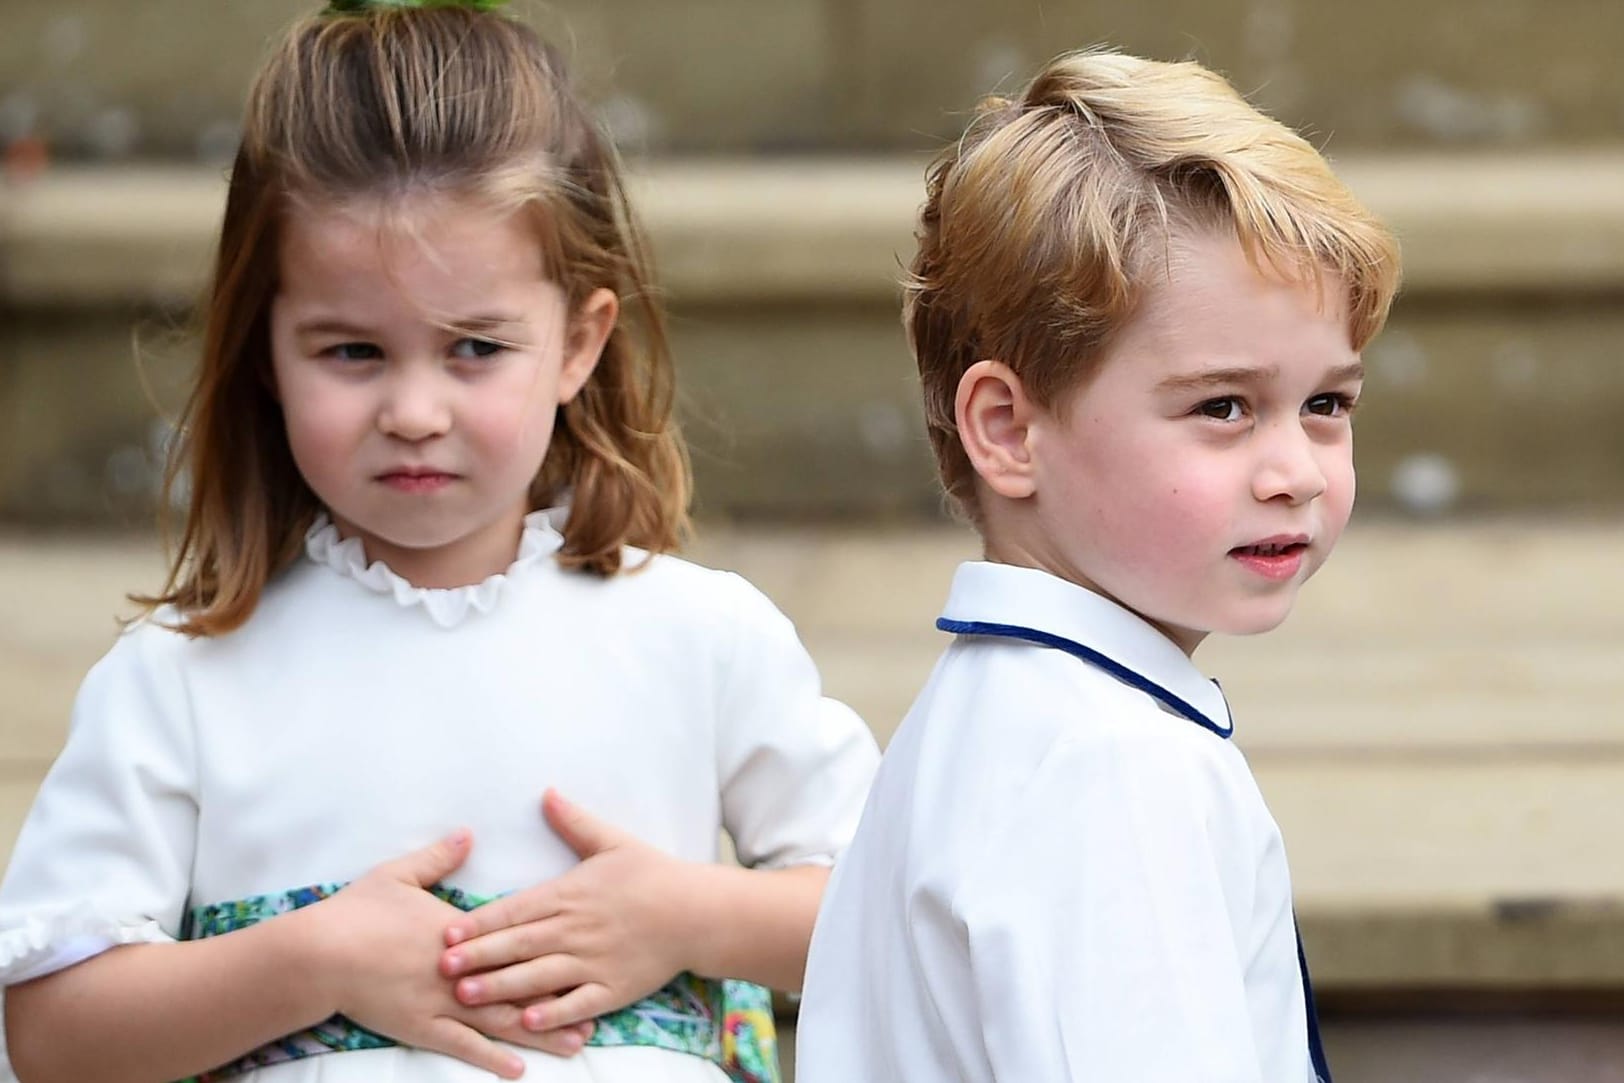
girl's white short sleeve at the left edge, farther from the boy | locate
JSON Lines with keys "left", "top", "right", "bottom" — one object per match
{"left": 0, "top": 625, "right": 198, "bottom": 986}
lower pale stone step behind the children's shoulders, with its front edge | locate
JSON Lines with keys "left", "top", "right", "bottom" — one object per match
{"left": 0, "top": 520, "right": 1624, "bottom": 1000}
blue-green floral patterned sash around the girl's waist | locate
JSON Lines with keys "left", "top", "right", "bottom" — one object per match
{"left": 180, "top": 883, "right": 780, "bottom": 1083}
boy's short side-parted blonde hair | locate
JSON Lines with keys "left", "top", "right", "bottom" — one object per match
{"left": 903, "top": 50, "right": 1398, "bottom": 521}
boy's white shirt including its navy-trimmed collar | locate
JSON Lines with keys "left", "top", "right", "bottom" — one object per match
{"left": 796, "top": 563, "right": 1314, "bottom": 1083}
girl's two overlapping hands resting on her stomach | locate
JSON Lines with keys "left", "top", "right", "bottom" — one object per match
{"left": 319, "top": 791, "right": 705, "bottom": 1077}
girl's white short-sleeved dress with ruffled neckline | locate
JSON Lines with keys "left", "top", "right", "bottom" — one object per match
{"left": 0, "top": 511, "right": 877, "bottom": 1083}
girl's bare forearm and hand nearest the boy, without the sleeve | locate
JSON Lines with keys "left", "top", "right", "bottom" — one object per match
{"left": 442, "top": 791, "right": 828, "bottom": 1031}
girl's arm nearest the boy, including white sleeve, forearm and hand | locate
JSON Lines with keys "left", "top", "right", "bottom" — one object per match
{"left": 442, "top": 573, "right": 879, "bottom": 1028}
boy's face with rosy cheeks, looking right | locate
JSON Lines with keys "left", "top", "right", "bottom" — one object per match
{"left": 1023, "top": 235, "right": 1363, "bottom": 651}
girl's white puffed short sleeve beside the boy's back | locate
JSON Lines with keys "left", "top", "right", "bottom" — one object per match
{"left": 716, "top": 576, "right": 879, "bottom": 869}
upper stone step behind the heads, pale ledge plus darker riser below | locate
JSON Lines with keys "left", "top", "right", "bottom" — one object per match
{"left": 0, "top": 151, "right": 1624, "bottom": 524}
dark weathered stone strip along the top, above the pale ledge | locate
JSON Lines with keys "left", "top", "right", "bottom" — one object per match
{"left": 0, "top": 0, "right": 1624, "bottom": 161}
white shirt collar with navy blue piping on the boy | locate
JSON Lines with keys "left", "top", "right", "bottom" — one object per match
{"left": 937, "top": 560, "right": 1234, "bottom": 737}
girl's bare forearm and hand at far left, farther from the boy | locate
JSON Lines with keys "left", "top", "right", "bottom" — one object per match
{"left": 5, "top": 831, "right": 525, "bottom": 1083}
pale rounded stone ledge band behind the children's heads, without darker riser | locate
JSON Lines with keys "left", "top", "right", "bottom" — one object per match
{"left": 0, "top": 151, "right": 1624, "bottom": 309}
